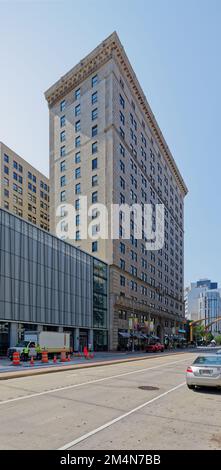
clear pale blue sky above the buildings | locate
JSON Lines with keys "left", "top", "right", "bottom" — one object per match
{"left": 0, "top": 0, "right": 221, "bottom": 285}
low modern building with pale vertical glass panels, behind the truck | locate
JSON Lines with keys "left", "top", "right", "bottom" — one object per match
{"left": 0, "top": 209, "right": 109, "bottom": 352}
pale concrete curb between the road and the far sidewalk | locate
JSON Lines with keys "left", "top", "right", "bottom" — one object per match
{"left": 0, "top": 351, "right": 190, "bottom": 380}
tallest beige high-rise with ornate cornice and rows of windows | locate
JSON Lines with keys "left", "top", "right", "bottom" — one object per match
{"left": 45, "top": 33, "right": 187, "bottom": 349}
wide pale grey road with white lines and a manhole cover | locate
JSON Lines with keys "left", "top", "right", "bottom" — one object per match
{"left": 0, "top": 352, "right": 221, "bottom": 450}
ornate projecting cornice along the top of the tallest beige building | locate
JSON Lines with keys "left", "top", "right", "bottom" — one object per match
{"left": 45, "top": 32, "right": 188, "bottom": 196}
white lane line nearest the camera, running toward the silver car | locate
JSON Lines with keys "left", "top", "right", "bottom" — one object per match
{"left": 58, "top": 382, "right": 186, "bottom": 450}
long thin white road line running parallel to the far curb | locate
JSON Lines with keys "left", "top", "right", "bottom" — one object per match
{"left": 0, "top": 359, "right": 187, "bottom": 405}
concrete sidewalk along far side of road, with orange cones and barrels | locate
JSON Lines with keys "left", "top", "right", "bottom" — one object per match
{"left": 0, "top": 349, "right": 190, "bottom": 380}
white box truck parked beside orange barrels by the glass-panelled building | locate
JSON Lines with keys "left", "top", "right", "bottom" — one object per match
{"left": 8, "top": 331, "right": 71, "bottom": 360}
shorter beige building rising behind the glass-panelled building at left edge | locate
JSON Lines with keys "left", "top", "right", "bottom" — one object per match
{"left": 0, "top": 142, "right": 50, "bottom": 231}
